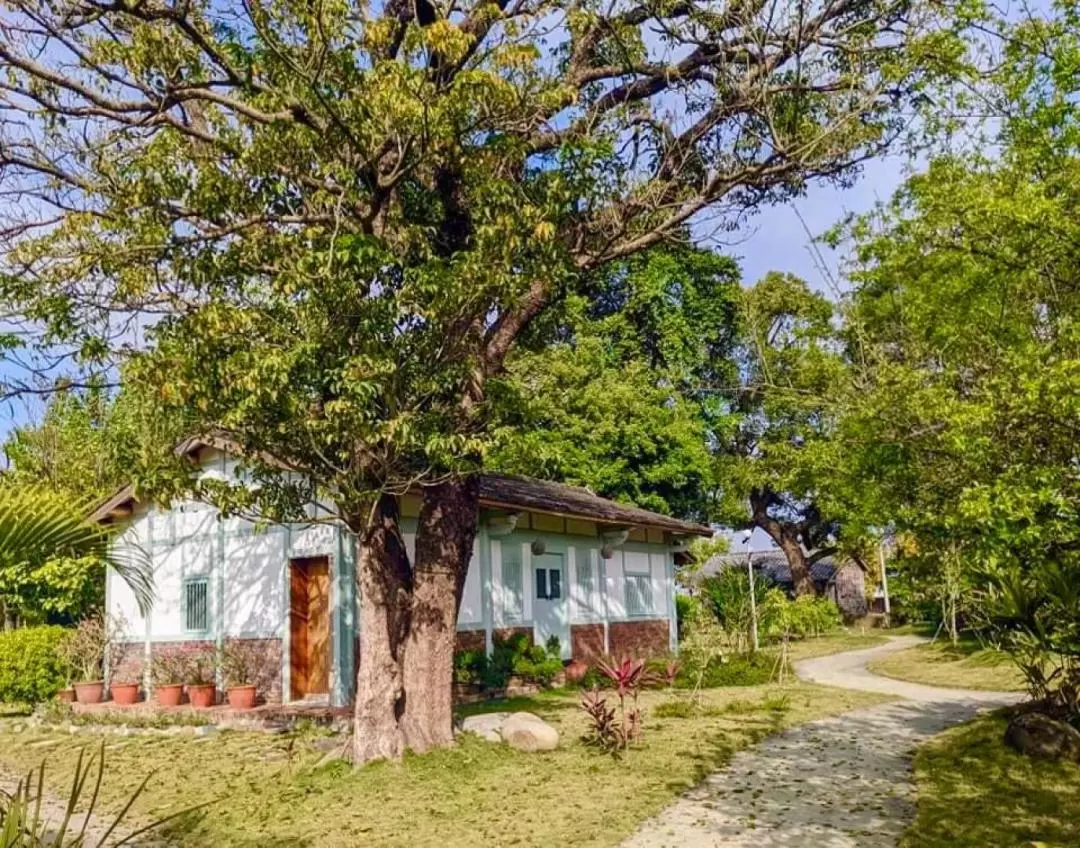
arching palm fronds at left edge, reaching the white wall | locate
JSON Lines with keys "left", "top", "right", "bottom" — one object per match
{"left": 0, "top": 486, "right": 154, "bottom": 615}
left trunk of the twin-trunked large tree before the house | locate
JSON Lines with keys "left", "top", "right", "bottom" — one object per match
{"left": 353, "top": 495, "right": 411, "bottom": 765}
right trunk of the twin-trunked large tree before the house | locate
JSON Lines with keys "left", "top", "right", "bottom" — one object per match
{"left": 402, "top": 479, "right": 480, "bottom": 753}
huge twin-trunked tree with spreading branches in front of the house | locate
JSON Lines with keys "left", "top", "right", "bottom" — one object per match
{"left": 0, "top": 0, "right": 957, "bottom": 762}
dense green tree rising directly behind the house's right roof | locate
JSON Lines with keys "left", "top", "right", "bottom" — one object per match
{"left": 488, "top": 241, "right": 740, "bottom": 521}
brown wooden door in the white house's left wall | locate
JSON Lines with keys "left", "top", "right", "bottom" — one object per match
{"left": 288, "top": 556, "right": 330, "bottom": 699}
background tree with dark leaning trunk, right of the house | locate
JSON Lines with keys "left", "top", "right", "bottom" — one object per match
{"left": 716, "top": 273, "right": 848, "bottom": 595}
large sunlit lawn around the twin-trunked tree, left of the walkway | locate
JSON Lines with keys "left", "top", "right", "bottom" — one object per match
{"left": 0, "top": 684, "right": 885, "bottom": 848}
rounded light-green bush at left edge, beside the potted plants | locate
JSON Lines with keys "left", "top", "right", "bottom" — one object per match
{"left": 0, "top": 627, "right": 70, "bottom": 703}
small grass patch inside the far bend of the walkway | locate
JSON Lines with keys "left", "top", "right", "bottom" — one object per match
{"left": 869, "top": 640, "right": 1024, "bottom": 691}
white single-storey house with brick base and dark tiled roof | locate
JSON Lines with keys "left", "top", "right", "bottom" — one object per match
{"left": 95, "top": 440, "right": 711, "bottom": 705}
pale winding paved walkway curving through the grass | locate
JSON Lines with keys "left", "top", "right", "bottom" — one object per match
{"left": 623, "top": 636, "right": 1020, "bottom": 848}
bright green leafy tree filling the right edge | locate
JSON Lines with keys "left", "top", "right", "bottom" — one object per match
{"left": 840, "top": 4, "right": 1080, "bottom": 715}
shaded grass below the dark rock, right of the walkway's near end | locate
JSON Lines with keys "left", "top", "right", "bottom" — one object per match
{"left": 901, "top": 715, "right": 1080, "bottom": 848}
